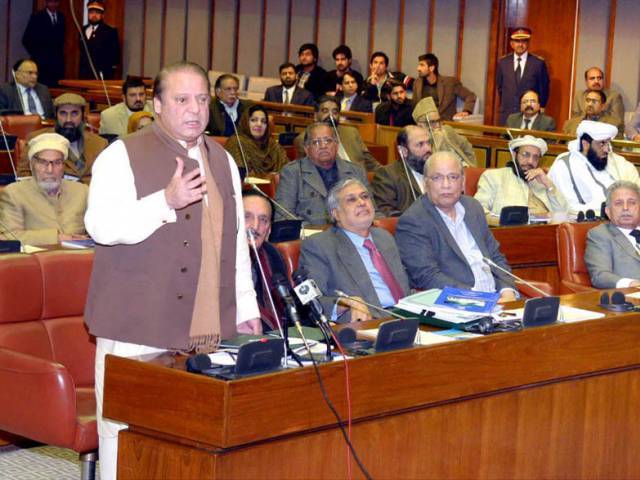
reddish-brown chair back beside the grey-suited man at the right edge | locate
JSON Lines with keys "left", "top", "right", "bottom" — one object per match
{"left": 556, "top": 223, "right": 596, "bottom": 293}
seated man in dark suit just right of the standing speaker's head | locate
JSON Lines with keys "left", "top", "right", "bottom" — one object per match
{"left": 207, "top": 73, "right": 253, "bottom": 137}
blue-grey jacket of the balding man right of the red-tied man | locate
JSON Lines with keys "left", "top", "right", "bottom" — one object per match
{"left": 396, "top": 195, "right": 515, "bottom": 290}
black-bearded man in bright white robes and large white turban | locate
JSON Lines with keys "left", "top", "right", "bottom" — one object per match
{"left": 549, "top": 120, "right": 640, "bottom": 214}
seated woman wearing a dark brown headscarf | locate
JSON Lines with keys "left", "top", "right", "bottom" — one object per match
{"left": 224, "top": 105, "right": 289, "bottom": 175}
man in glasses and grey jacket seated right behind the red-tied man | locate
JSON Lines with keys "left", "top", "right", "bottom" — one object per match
{"left": 276, "top": 122, "right": 368, "bottom": 224}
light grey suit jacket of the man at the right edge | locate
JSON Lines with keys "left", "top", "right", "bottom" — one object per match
{"left": 584, "top": 223, "right": 640, "bottom": 288}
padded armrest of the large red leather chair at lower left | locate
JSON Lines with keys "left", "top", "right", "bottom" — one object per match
{"left": 0, "top": 347, "right": 76, "bottom": 447}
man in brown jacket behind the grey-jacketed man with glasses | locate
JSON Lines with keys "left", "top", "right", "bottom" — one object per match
{"left": 293, "top": 95, "right": 380, "bottom": 172}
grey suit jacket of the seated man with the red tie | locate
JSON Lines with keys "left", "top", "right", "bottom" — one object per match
{"left": 300, "top": 227, "right": 409, "bottom": 320}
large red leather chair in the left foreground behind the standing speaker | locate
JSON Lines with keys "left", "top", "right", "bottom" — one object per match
{"left": 0, "top": 251, "right": 98, "bottom": 478}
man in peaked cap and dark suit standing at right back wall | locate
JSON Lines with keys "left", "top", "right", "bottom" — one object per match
{"left": 496, "top": 27, "right": 549, "bottom": 125}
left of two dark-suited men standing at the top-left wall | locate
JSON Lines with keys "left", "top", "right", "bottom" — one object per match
{"left": 22, "top": 0, "right": 64, "bottom": 87}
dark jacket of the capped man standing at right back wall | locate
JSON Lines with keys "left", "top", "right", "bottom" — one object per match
{"left": 496, "top": 52, "right": 549, "bottom": 125}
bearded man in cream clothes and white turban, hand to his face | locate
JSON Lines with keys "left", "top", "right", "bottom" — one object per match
{"left": 474, "top": 135, "right": 569, "bottom": 225}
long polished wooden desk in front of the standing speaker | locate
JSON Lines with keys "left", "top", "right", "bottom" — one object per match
{"left": 104, "top": 293, "right": 640, "bottom": 479}
